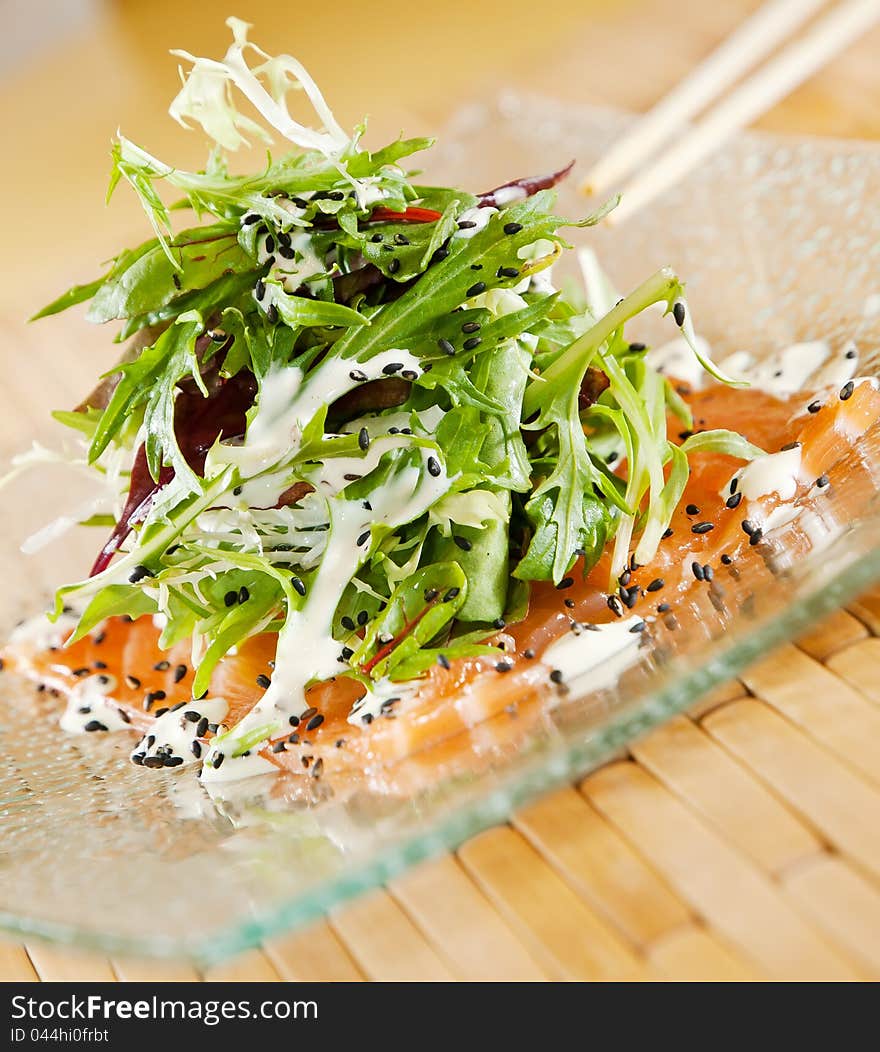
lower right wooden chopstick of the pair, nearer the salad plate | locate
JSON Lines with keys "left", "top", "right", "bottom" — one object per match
{"left": 584, "top": 0, "right": 880, "bottom": 225}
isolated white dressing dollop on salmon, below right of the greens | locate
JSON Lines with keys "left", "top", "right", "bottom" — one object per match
{"left": 540, "top": 615, "right": 644, "bottom": 692}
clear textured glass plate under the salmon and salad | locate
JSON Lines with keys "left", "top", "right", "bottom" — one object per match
{"left": 0, "top": 93, "right": 880, "bottom": 964}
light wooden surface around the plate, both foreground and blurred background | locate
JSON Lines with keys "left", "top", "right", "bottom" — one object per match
{"left": 0, "top": 0, "right": 880, "bottom": 980}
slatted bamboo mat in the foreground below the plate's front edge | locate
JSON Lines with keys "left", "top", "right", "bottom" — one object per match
{"left": 0, "top": 588, "right": 880, "bottom": 982}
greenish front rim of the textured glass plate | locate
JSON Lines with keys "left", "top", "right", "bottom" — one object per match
{"left": 0, "top": 104, "right": 880, "bottom": 967}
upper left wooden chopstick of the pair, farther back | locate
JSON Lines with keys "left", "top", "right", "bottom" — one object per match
{"left": 581, "top": 0, "right": 827, "bottom": 194}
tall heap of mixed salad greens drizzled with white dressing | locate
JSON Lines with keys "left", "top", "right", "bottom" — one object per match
{"left": 24, "top": 19, "right": 742, "bottom": 761}
